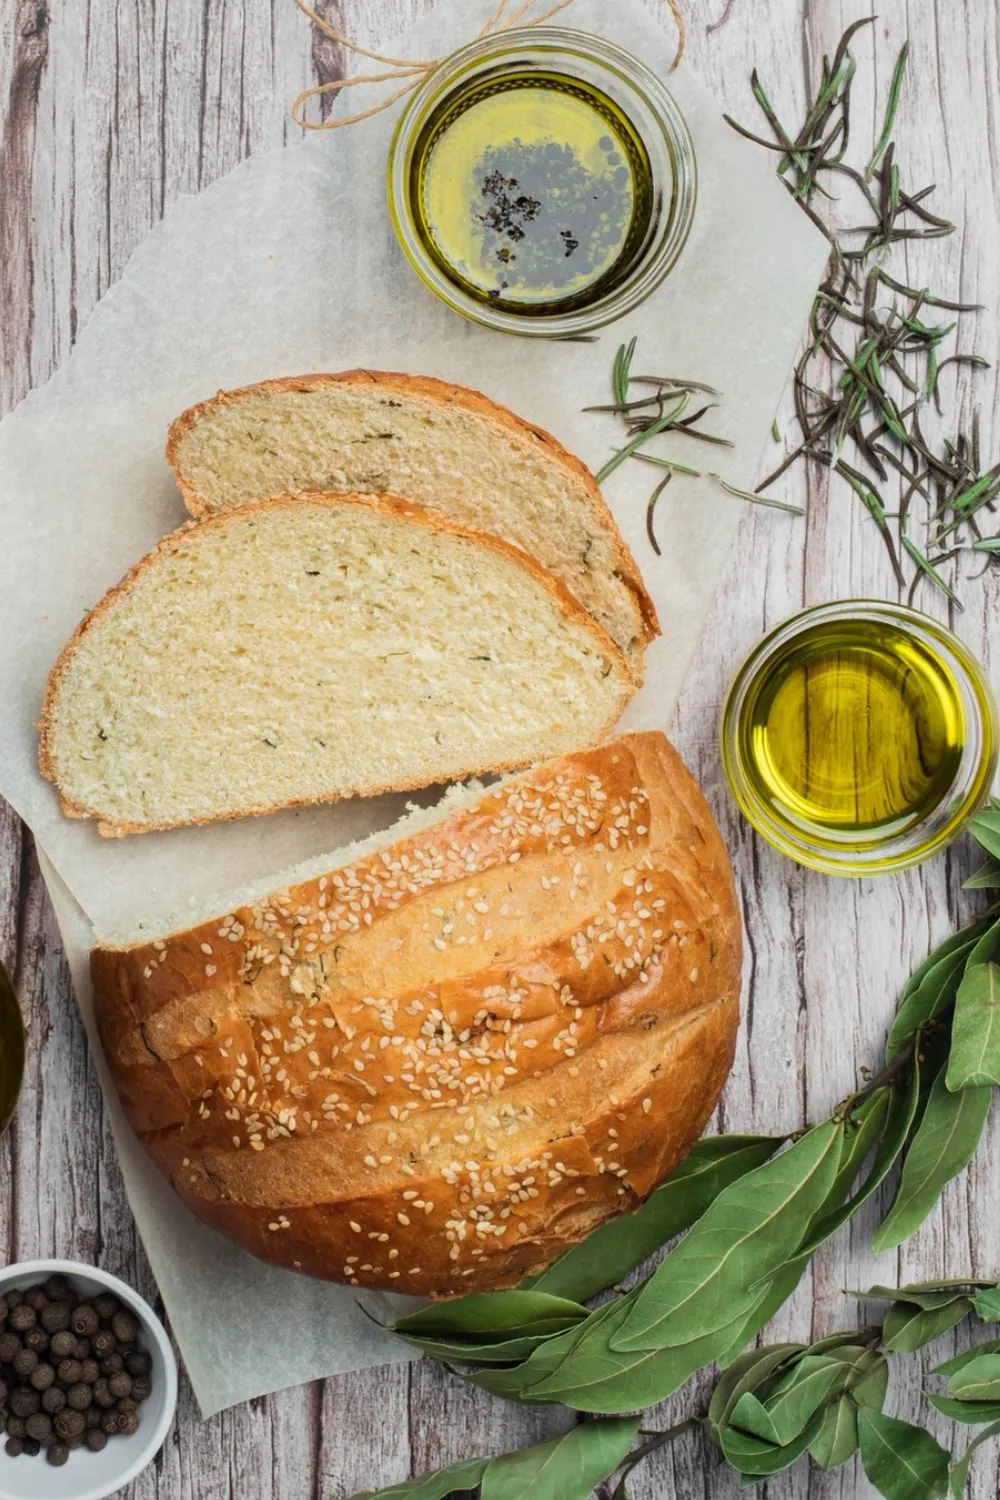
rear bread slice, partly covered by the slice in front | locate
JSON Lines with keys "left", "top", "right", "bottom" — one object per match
{"left": 166, "top": 371, "right": 658, "bottom": 657}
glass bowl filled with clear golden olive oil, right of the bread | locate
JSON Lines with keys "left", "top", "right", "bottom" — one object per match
{"left": 723, "top": 600, "right": 999, "bottom": 876}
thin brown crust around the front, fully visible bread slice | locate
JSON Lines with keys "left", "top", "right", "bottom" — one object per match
{"left": 39, "top": 491, "right": 642, "bottom": 839}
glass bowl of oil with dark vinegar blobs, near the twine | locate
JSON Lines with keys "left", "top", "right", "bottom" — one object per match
{"left": 388, "top": 27, "right": 697, "bottom": 338}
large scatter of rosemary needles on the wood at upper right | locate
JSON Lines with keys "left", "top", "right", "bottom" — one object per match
{"left": 727, "top": 17, "right": 1000, "bottom": 608}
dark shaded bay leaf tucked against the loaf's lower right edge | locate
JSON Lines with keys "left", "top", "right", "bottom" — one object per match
{"left": 525, "top": 1136, "right": 781, "bottom": 1302}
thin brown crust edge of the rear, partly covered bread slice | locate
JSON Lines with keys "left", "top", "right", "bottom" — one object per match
{"left": 166, "top": 369, "right": 660, "bottom": 645}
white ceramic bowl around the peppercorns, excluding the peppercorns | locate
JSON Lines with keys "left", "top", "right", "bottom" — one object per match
{"left": 0, "top": 1260, "right": 177, "bottom": 1500}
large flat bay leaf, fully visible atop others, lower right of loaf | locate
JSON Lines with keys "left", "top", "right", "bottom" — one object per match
{"left": 615, "top": 1121, "right": 844, "bottom": 1358}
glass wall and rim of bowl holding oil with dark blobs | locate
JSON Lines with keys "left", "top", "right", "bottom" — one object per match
{"left": 388, "top": 26, "right": 697, "bottom": 339}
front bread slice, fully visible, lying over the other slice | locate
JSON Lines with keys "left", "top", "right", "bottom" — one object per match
{"left": 40, "top": 495, "right": 637, "bottom": 836}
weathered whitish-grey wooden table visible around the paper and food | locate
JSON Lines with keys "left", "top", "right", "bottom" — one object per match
{"left": 0, "top": 0, "right": 1000, "bottom": 1500}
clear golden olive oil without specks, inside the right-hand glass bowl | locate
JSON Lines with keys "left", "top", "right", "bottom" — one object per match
{"left": 739, "top": 620, "right": 967, "bottom": 848}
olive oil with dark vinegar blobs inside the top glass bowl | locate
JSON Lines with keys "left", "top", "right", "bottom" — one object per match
{"left": 411, "top": 69, "right": 654, "bottom": 317}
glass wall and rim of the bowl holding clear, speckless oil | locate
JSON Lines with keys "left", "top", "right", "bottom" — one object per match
{"left": 721, "top": 599, "right": 1000, "bottom": 876}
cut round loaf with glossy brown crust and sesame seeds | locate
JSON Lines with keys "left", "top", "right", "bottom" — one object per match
{"left": 91, "top": 734, "right": 741, "bottom": 1298}
